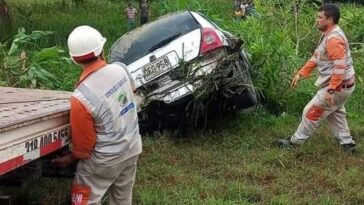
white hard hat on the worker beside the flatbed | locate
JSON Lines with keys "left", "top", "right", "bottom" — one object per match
{"left": 67, "top": 26, "right": 106, "bottom": 63}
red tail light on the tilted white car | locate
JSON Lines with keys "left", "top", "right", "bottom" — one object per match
{"left": 200, "top": 28, "right": 222, "bottom": 54}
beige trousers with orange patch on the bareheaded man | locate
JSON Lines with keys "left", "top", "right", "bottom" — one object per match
{"left": 291, "top": 86, "right": 355, "bottom": 145}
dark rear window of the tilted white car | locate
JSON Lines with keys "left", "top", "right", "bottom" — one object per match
{"left": 109, "top": 11, "right": 200, "bottom": 65}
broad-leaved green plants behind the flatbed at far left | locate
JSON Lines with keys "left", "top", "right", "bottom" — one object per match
{"left": 0, "top": 28, "right": 68, "bottom": 88}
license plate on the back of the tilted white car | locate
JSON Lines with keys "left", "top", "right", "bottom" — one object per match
{"left": 143, "top": 56, "right": 171, "bottom": 81}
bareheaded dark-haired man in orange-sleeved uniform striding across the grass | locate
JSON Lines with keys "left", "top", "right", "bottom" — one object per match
{"left": 278, "top": 4, "right": 356, "bottom": 152}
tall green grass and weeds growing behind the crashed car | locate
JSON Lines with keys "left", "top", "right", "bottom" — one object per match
{"left": 2, "top": 0, "right": 364, "bottom": 114}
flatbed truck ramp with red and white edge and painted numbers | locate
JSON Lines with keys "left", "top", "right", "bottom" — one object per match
{"left": 0, "top": 87, "right": 71, "bottom": 176}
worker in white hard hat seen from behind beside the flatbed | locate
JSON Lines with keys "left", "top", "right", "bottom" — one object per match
{"left": 52, "top": 26, "right": 142, "bottom": 205}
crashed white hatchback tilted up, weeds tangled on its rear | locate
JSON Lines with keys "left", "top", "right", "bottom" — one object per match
{"left": 109, "top": 11, "right": 257, "bottom": 131}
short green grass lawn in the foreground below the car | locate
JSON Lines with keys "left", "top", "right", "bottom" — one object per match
{"left": 134, "top": 111, "right": 364, "bottom": 204}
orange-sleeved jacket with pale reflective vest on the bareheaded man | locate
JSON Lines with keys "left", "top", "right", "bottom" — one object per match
{"left": 298, "top": 25, "right": 355, "bottom": 90}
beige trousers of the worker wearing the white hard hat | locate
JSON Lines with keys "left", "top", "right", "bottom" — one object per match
{"left": 72, "top": 156, "right": 138, "bottom": 205}
